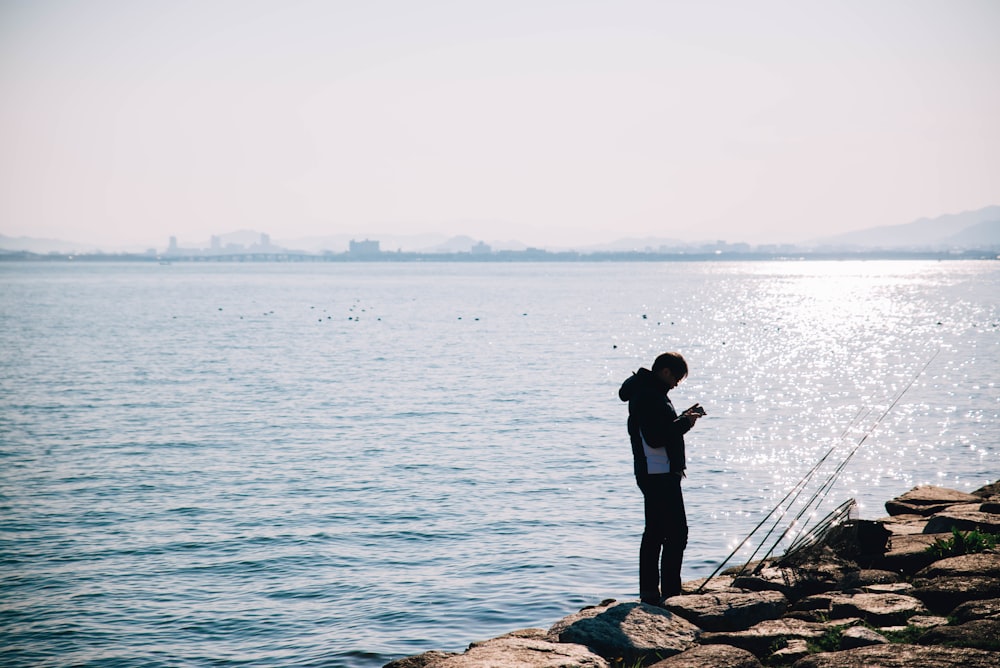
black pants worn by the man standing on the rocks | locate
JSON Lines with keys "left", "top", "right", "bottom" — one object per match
{"left": 636, "top": 473, "right": 687, "bottom": 604}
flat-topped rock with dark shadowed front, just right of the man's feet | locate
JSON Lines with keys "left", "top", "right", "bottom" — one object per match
{"left": 665, "top": 591, "right": 788, "bottom": 631}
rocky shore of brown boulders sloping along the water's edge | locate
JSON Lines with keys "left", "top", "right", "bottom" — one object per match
{"left": 385, "top": 482, "right": 1000, "bottom": 668}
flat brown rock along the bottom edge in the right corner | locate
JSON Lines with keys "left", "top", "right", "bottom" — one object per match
{"left": 794, "top": 643, "right": 1000, "bottom": 668}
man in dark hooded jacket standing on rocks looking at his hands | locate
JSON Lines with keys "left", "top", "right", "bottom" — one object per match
{"left": 618, "top": 353, "right": 705, "bottom": 605}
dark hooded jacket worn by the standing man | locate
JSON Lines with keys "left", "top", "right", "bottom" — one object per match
{"left": 618, "top": 368, "right": 691, "bottom": 475}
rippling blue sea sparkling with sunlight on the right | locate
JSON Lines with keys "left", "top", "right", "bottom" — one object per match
{"left": 0, "top": 260, "right": 1000, "bottom": 668}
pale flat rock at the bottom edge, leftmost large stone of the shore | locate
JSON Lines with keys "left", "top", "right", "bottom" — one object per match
{"left": 423, "top": 634, "right": 609, "bottom": 668}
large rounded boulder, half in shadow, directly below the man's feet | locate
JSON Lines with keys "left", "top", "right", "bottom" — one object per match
{"left": 549, "top": 602, "right": 701, "bottom": 663}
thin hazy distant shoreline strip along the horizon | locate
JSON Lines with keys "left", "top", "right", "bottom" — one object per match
{"left": 0, "top": 249, "right": 1000, "bottom": 264}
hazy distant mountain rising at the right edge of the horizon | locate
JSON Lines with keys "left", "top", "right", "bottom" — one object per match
{"left": 810, "top": 206, "right": 1000, "bottom": 250}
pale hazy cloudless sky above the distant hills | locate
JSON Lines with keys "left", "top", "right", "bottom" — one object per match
{"left": 0, "top": 0, "right": 1000, "bottom": 246}
